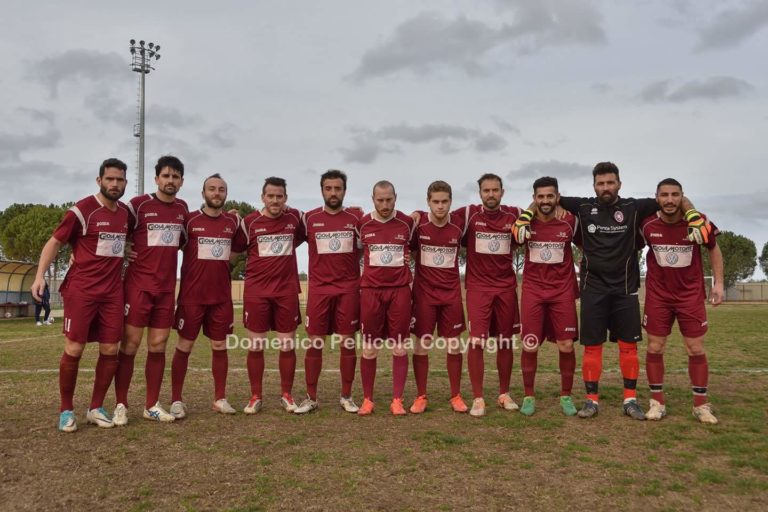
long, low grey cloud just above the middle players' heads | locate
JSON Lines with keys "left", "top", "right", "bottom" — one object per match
{"left": 339, "top": 123, "right": 507, "bottom": 163}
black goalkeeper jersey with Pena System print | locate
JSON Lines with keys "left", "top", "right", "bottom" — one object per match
{"left": 560, "top": 197, "right": 658, "bottom": 295}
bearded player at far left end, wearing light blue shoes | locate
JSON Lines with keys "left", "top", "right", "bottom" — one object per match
{"left": 32, "top": 158, "right": 129, "bottom": 432}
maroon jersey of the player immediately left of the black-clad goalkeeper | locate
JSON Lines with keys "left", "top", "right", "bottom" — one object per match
{"left": 523, "top": 213, "right": 578, "bottom": 300}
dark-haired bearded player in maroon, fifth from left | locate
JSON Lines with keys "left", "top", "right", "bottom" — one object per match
{"left": 295, "top": 170, "right": 362, "bottom": 414}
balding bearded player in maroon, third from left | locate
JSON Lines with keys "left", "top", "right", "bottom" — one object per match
{"left": 170, "top": 174, "right": 245, "bottom": 420}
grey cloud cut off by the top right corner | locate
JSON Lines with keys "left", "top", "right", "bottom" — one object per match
{"left": 695, "top": 0, "right": 768, "bottom": 51}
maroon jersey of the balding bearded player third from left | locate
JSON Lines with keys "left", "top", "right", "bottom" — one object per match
{"left": 178, "top": 210, "right": 245, "bottom": 304}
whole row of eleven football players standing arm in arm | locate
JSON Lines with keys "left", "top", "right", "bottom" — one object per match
{"left": 32, "top": 156, "right": 723, "bottom": 432}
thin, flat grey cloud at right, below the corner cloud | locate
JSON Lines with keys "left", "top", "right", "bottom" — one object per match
{"left": 638, "top": 76, "right": 755, "bottom": 103}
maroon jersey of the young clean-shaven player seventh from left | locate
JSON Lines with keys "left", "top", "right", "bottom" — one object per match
{"left": 411, "top": 212, "right": 465, "bottom": 304}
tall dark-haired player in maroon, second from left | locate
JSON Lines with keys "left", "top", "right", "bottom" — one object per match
{"left": 113, "top": 155, "right": 189, "bottom": 425}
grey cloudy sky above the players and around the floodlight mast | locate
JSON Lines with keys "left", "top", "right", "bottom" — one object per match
{"left": 0, "top": 0, "right": 768, "bottom": 276}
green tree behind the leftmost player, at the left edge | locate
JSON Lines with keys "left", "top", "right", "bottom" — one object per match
{"left": 0, "top": 205, "right": 71, "bottom": 277}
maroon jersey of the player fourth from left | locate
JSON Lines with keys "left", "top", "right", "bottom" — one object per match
{"left": 240, "top": 208, "right": 304, "bottom": 299}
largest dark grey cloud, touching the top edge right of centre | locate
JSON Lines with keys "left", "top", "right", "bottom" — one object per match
{"left": 351, "top": 0, "right": 605, "bottom": 83}
